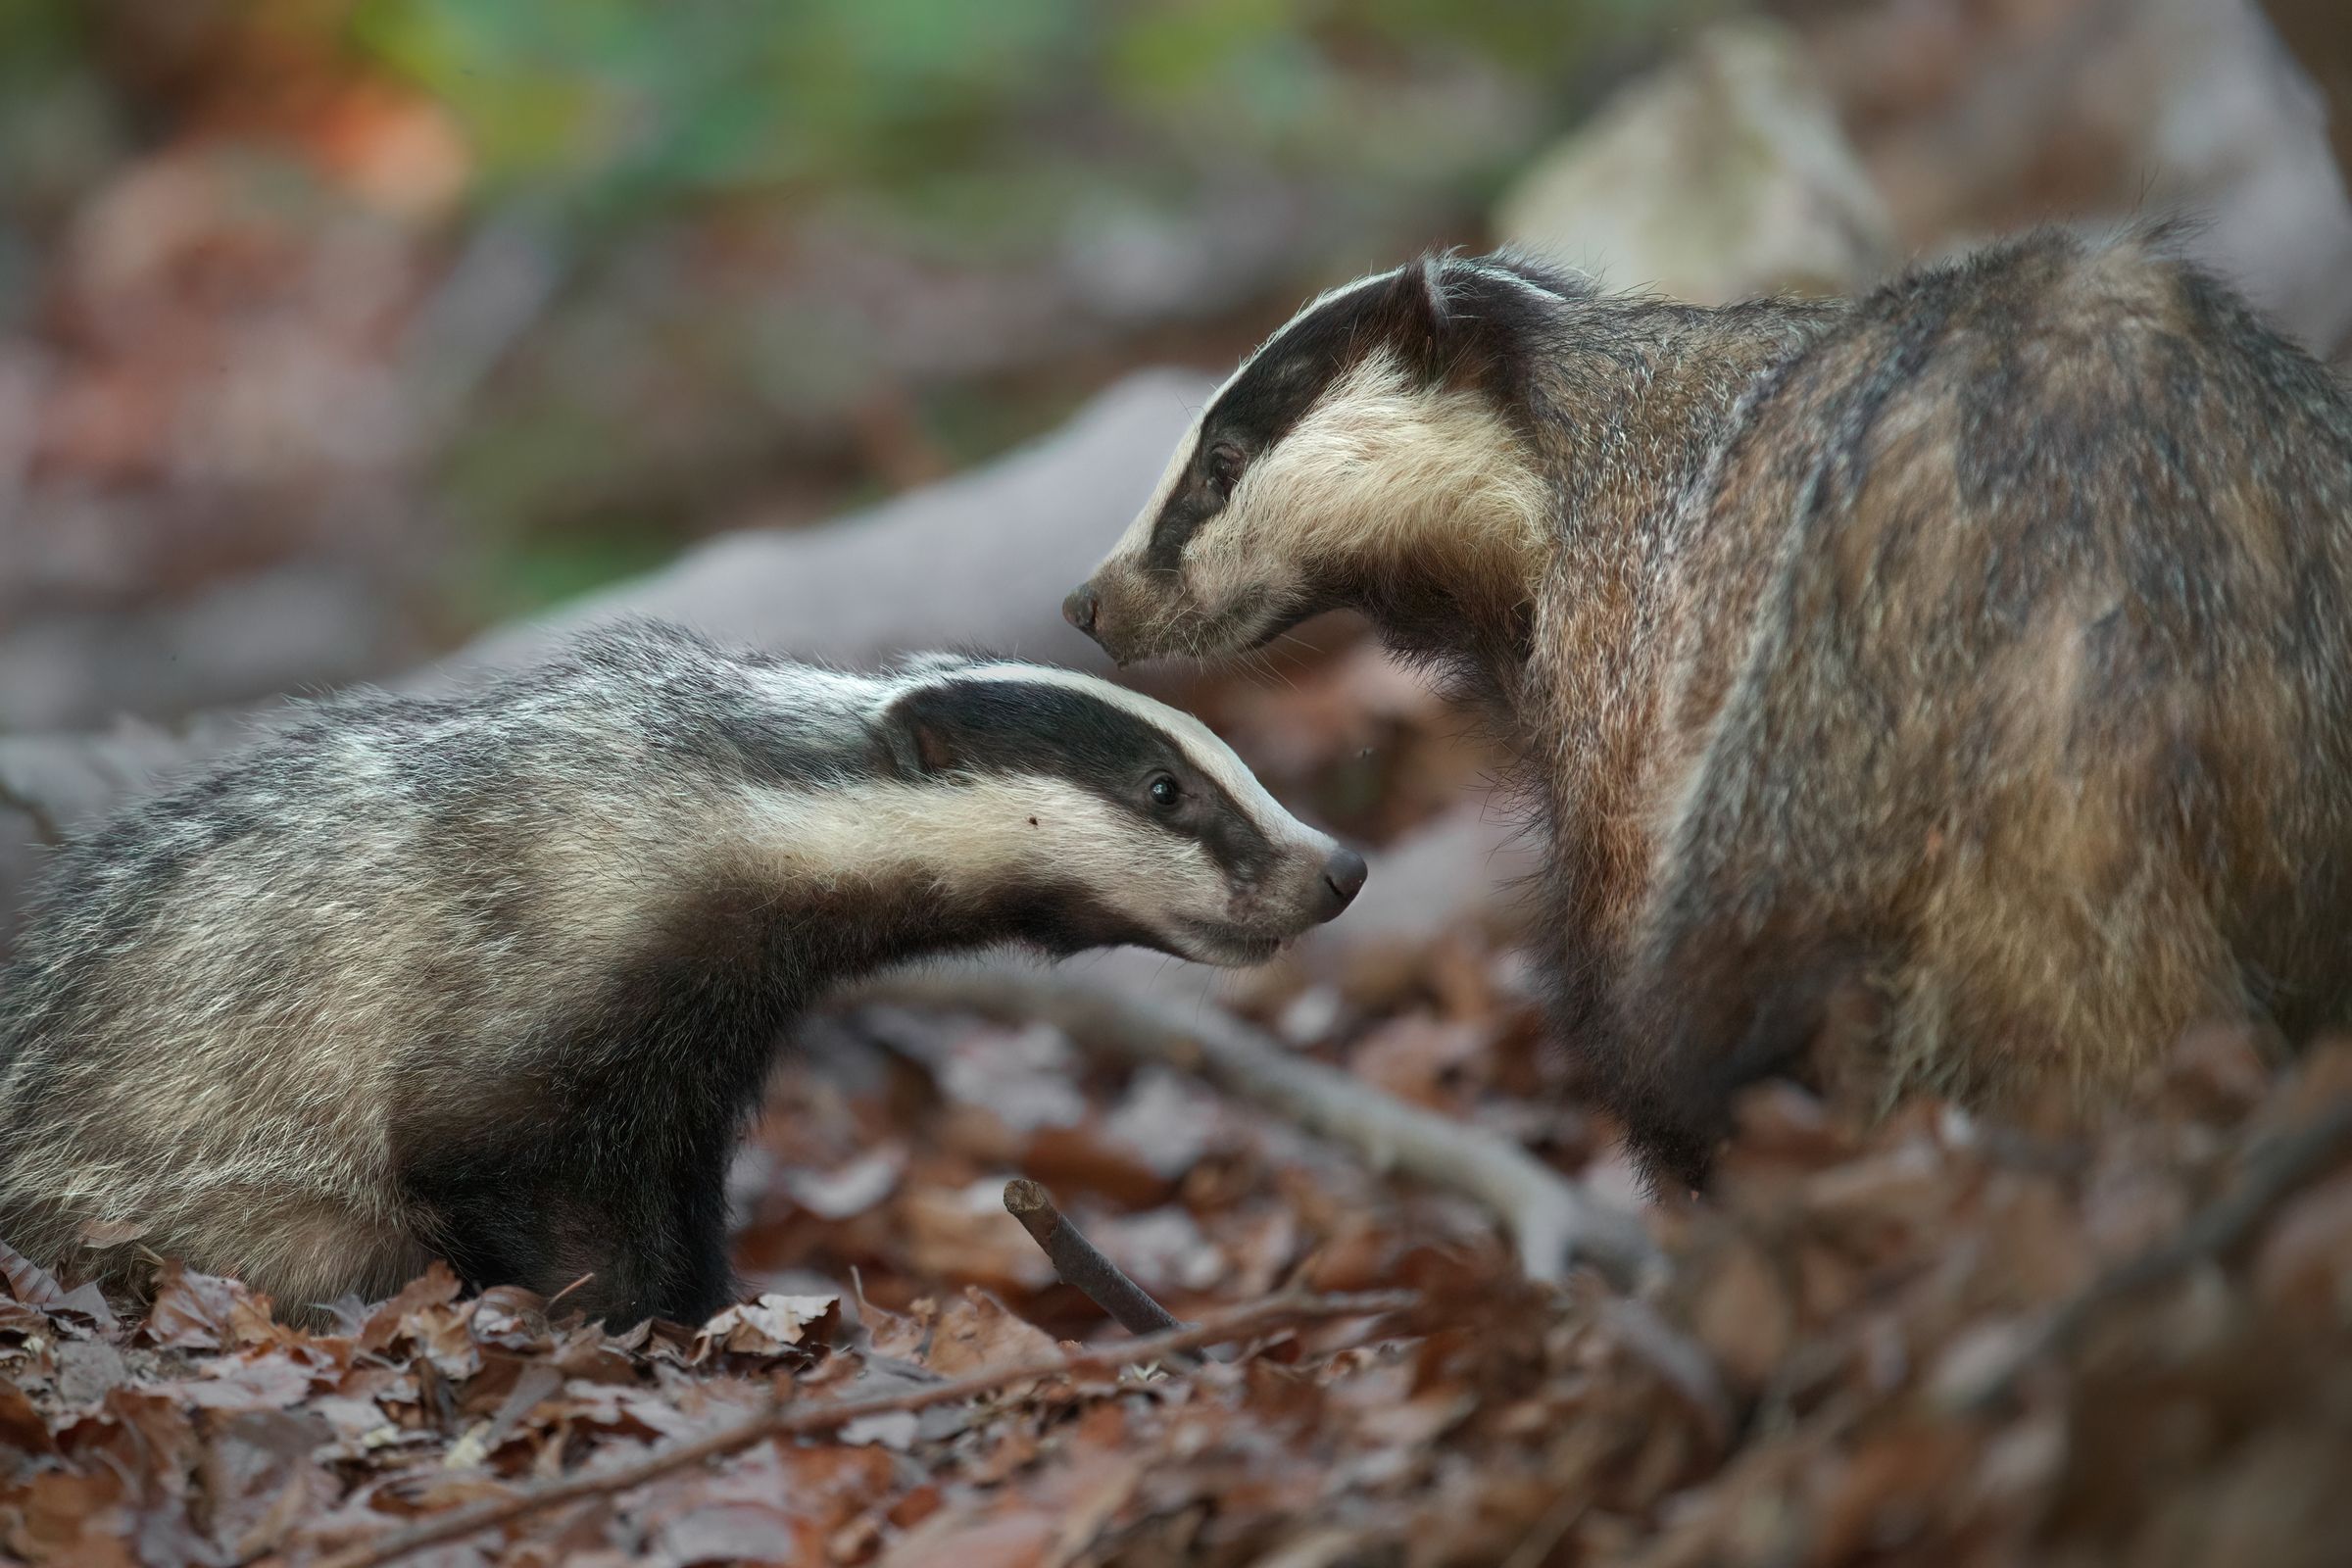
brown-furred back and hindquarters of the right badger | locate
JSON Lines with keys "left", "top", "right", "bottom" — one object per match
{"left": 1552, "top": 235, "right": 2352, "bottom": 1184}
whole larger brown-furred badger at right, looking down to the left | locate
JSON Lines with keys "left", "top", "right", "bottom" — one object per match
{"left": 1065, "top": 230, "right": 2352, "bottom": 1185}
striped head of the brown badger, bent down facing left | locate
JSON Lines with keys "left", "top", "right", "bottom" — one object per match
{"left": 1063, "top": 259, "right": 1590, "bottom": 662}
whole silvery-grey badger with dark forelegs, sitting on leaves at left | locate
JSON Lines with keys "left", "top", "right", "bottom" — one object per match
{"left": 0, "top": 625, "right": 1364, "bottom": 1324}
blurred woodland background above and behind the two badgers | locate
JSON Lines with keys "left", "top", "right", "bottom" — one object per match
{"left": 0, "top": 0, "right": 2352, "bottom": 906}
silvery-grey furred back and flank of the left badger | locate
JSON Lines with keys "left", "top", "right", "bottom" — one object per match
{"left": 0, "top": 630, "right": 847, "bottom": 1293}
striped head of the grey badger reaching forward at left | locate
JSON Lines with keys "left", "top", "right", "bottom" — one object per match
{"left": 872, "top": 659, "right": 1364, "bottom": 966}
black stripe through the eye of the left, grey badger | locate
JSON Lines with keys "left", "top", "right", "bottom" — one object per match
{"left": 901, "top": 679, "right": 1280, "bottom": 879}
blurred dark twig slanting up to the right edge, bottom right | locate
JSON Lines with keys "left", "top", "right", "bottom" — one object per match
{"left": 1950, "top": 1096, "right": 2352, "bottom": 1415}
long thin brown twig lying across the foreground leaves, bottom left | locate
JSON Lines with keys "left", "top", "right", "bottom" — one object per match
{"left": 313, "top": 1291, "right": 1421, "bottom": 1568}
